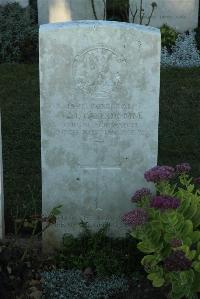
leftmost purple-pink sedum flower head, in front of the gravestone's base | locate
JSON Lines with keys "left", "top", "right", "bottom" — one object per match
{"left": 122, "top": 208, "right": 147, "bottom": 227}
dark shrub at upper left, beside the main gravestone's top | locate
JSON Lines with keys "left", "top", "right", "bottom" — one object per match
{"left": 0, "top": 3, "right": 38, "bottom": 63}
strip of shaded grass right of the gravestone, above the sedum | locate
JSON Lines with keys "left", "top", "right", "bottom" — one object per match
{"left": 158, "top": 68, "right": 200, "bottom": 176}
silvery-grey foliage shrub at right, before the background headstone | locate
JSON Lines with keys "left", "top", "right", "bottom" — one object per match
{"left": 161, "top": 32, "right": 200, "bottom": 67}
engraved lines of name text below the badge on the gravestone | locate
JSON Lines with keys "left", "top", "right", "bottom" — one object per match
{"left": 57, "top": 102, "right": 143, "bottom": 140}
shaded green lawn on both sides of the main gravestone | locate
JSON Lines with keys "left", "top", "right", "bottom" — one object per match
{"left": 0, "top": 65, "right": 200, "bottom": 231}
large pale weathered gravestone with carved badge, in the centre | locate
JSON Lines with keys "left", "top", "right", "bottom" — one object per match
{"left": 40, "top": 21, "right": 160, "bottom": 248}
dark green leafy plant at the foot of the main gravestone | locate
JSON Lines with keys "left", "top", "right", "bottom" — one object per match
{"left": 56, "top": 222, "right": 142, "bottom": 277}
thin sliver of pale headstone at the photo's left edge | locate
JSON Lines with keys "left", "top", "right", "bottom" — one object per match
{"left": 0, "top": 112, "right": 4, "bottom": 239}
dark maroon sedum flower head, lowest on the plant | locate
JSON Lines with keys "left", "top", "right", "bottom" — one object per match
{"left": 164, "top": 250, "right": 192, "bottom": 272}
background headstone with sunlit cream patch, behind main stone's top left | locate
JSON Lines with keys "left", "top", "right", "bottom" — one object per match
{"left": 38, "top": 0, "right": 104, "bottom": 24}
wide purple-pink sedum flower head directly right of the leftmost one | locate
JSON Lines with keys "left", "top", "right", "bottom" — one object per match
{"left": 150, "top": 195, "right": 180, "bottom": 210}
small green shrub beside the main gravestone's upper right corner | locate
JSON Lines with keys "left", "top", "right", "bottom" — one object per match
{"left": 160, "top": 24, "right": 178, "bottom": 51}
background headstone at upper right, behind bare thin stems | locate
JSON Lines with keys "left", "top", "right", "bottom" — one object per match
{"left": 130, "top": 0, "right": 199, "bottom": 32}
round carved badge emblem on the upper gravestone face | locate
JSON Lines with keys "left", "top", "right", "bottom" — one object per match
{"left": 73, "top": 46, "right": 126, "bottom": 99}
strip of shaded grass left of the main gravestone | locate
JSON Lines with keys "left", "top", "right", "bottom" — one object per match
{"left": 0, "top": 65, "right": 41, "bottom": 230}
